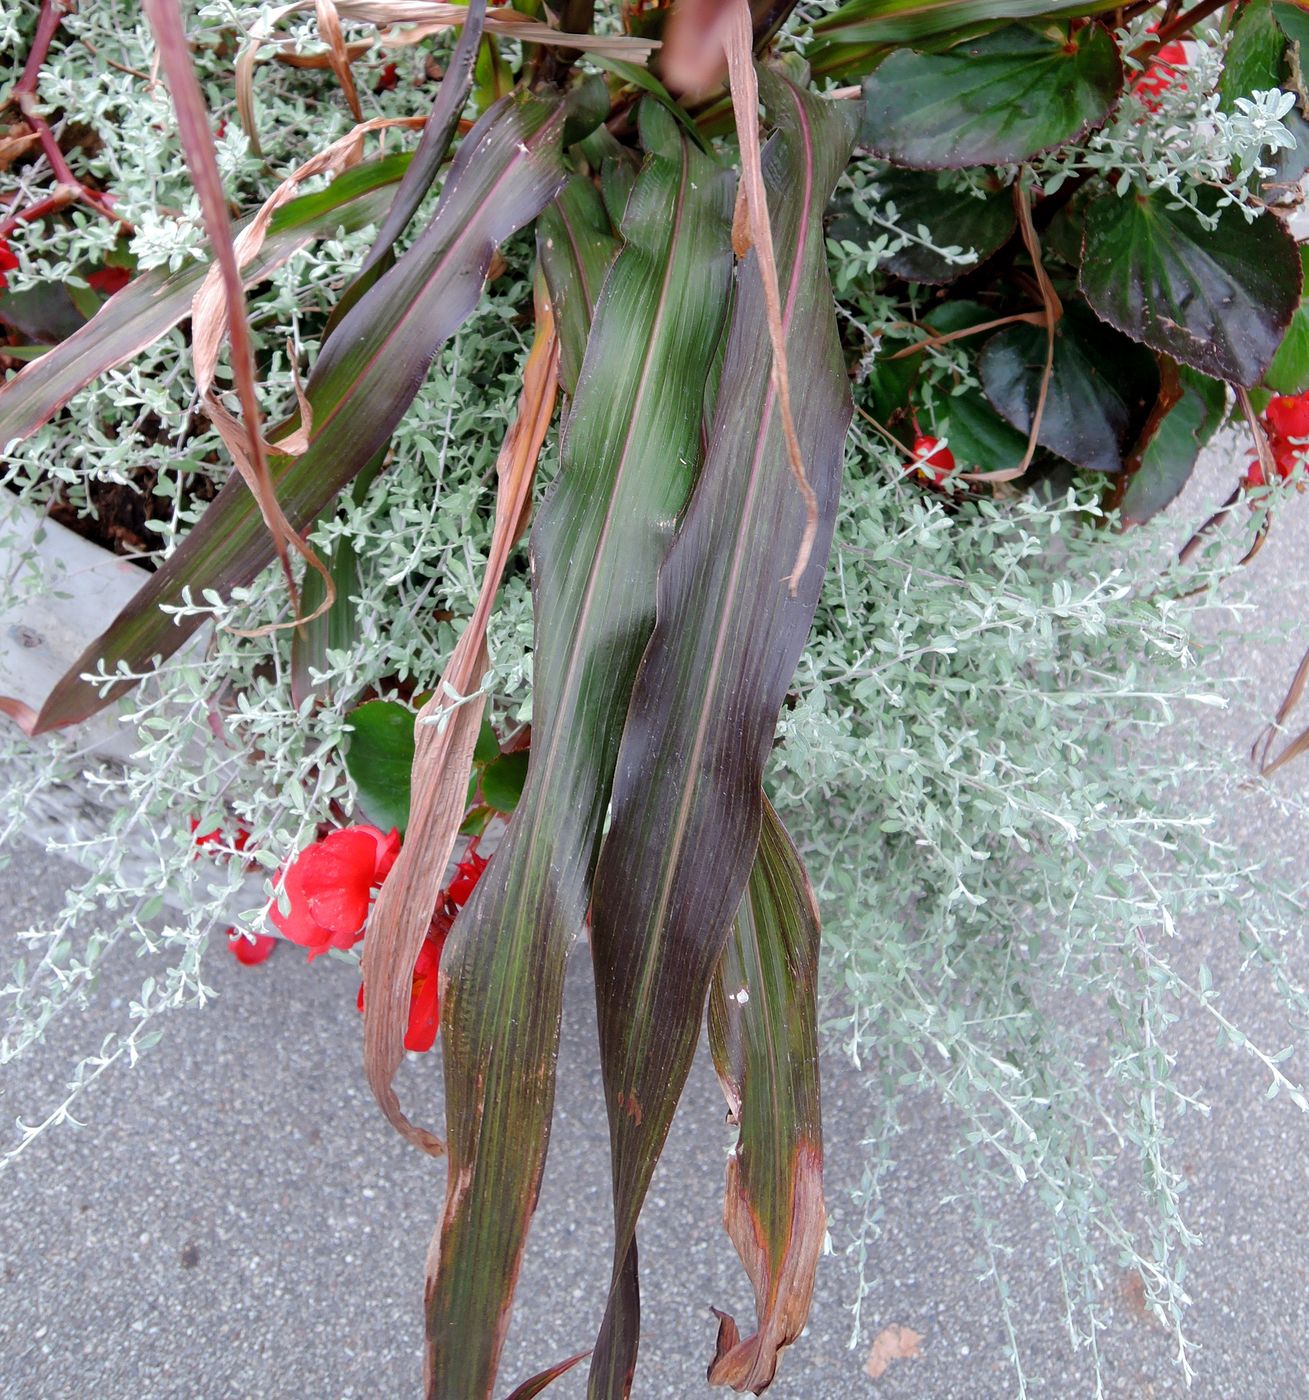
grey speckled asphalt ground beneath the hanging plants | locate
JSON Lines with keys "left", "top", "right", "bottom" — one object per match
{"left": 0, "top": 450, "right": 1309, "bottom": 1400}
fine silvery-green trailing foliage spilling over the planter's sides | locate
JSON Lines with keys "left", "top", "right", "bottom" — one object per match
{"left": 0, "top": 0, "right": 1309, "bottom": 1390}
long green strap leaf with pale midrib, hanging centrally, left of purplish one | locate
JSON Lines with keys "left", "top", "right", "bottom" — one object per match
{"left": 427, "top": 102, "right": 732, "bottom": 1400}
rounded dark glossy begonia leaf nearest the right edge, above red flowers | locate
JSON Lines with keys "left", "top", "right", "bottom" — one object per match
{"left": 1079, "top": 188, "right": 1303, "bottom": 389}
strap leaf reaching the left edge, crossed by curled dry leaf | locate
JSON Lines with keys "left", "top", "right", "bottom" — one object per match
{"left": 0, "top": 153, "right": 409, "bottom": 449}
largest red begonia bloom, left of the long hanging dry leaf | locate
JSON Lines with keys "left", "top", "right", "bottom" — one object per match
{"left": 269, "top": 826, "right": 400, "bottom": 959}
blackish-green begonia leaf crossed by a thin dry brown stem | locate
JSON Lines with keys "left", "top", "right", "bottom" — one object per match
{"left": 979, "top": 302, "right": 1159, "bottom": 472}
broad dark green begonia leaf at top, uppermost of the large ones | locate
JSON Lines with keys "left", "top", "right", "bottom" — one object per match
{"left": 860, "top": 22, "right": 1123, "bottom": 169}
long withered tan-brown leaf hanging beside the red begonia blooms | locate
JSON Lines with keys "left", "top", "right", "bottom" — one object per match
{"left": 363, "top": 279, "right": 559, "bottom": 1155}
